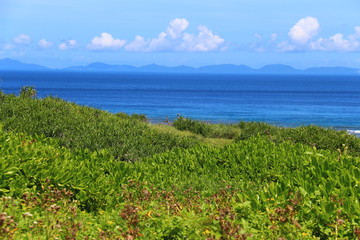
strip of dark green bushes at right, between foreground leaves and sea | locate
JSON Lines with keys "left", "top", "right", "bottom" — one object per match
{"left": 174, "top": 117, "right": 360, "bottom": 156}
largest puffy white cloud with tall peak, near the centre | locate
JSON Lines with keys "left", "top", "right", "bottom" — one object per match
{"left": 125, "top": 18, "right": 224, "bottom": 52}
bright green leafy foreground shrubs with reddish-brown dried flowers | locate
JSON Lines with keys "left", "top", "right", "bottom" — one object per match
{"left": 0, "top": 132, "right": 360, "bottom": 239}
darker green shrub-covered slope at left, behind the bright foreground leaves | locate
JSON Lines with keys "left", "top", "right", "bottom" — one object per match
{"left": 0, "top": 95, "right": 197, "bottom": 161}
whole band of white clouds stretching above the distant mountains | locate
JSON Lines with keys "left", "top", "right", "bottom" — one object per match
{"left": 0, "top": 16, "right": 360, "bottom": 53}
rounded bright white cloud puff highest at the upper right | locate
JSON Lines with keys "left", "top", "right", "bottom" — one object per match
{"left": 289, "top": 17, "right": 320, "bottom": 45}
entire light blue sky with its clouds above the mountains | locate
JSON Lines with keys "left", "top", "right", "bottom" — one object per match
{"left": 0, "top": 0, "right": 360, "bottom": 69}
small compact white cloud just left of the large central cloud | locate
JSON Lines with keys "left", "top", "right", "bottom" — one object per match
{"left": 87, "top": 33, "right": 126, "bottom": 50}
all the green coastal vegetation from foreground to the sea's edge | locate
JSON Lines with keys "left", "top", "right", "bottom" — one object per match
{"left": 0, "top": 89, "right": 360, "bottom": 239}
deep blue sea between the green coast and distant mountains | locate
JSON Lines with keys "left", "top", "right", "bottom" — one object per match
{"left": 0, "top": 72, "right": 360, "bottom": 133}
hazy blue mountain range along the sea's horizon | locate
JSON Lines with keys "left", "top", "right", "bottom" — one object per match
{"left": 0, "top": 58, "right": 360, "bottom": 75}
